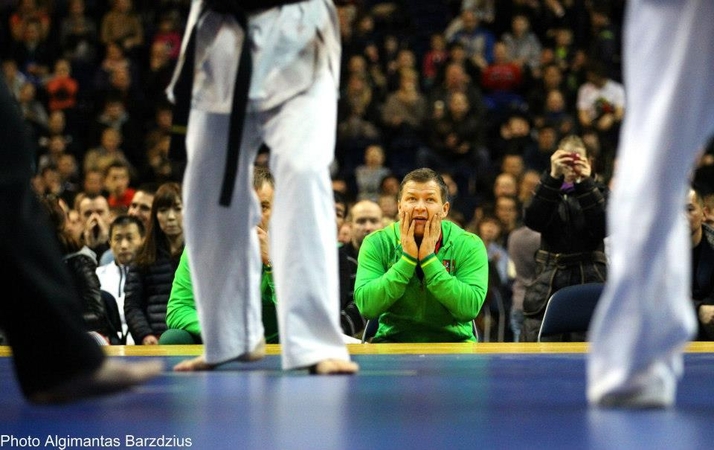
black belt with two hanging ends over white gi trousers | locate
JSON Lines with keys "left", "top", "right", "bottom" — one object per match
{"left": 169, "top": 0, "right": 305, "bottom": 207}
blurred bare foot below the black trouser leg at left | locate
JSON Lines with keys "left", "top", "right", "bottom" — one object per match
{"left": 29, "top": 358, "right": 164, "bottom": 404}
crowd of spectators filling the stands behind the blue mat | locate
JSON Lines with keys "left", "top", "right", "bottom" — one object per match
{"left": 0, "top": 0, "right": 714, "bottom": 344}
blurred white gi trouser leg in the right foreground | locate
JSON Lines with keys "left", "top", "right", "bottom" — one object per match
{"left": 587, "top": 0, "right": 714, "bottom": 405}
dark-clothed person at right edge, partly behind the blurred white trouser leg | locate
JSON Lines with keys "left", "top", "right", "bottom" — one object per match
{"left": 687, "top": 188, "right": 714, "bottom": 341}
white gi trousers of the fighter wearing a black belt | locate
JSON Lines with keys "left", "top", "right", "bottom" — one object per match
{"left": 179, "top": 0, "right": 349, "bottom": 369}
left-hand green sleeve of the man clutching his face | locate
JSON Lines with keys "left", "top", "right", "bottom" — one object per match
{"left": 354, "top": 230, "right": 417, "bottom": 319}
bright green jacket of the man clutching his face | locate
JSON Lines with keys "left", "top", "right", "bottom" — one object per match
{"left": 354, "top": 221, "right": 488, "bottom": 342}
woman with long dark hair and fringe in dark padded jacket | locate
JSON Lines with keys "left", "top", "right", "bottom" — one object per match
{"left": 124, "top": 183, "right": 184, "bottom": 345}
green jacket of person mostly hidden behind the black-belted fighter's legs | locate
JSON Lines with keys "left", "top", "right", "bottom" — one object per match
{"left": 166, "top": 248, "right": 278, "bottom": 344}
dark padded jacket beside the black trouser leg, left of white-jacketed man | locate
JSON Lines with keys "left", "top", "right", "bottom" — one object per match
{"left": 64, "top": 247, "right": 110, "bottom": 336}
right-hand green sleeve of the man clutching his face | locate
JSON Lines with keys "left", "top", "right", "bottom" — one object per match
{"left": 421, "top": 235, "right": 488, "bottom": 322}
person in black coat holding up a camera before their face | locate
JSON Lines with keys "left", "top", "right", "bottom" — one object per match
{"left": 523, "top": 136, "right": 607, "bottom": 342}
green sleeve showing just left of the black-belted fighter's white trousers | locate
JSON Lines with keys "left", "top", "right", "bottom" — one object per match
{"left": 166, "top": 248, "right": 201, "bottom": 335}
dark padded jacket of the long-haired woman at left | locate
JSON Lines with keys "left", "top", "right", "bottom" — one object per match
{"left": 124, "top": 250, "right": 179, "bottom": 344}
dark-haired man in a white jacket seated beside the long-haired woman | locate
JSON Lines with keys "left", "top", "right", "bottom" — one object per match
{"left": 97, "top": 215, "right": 146, "bottom": 344}
